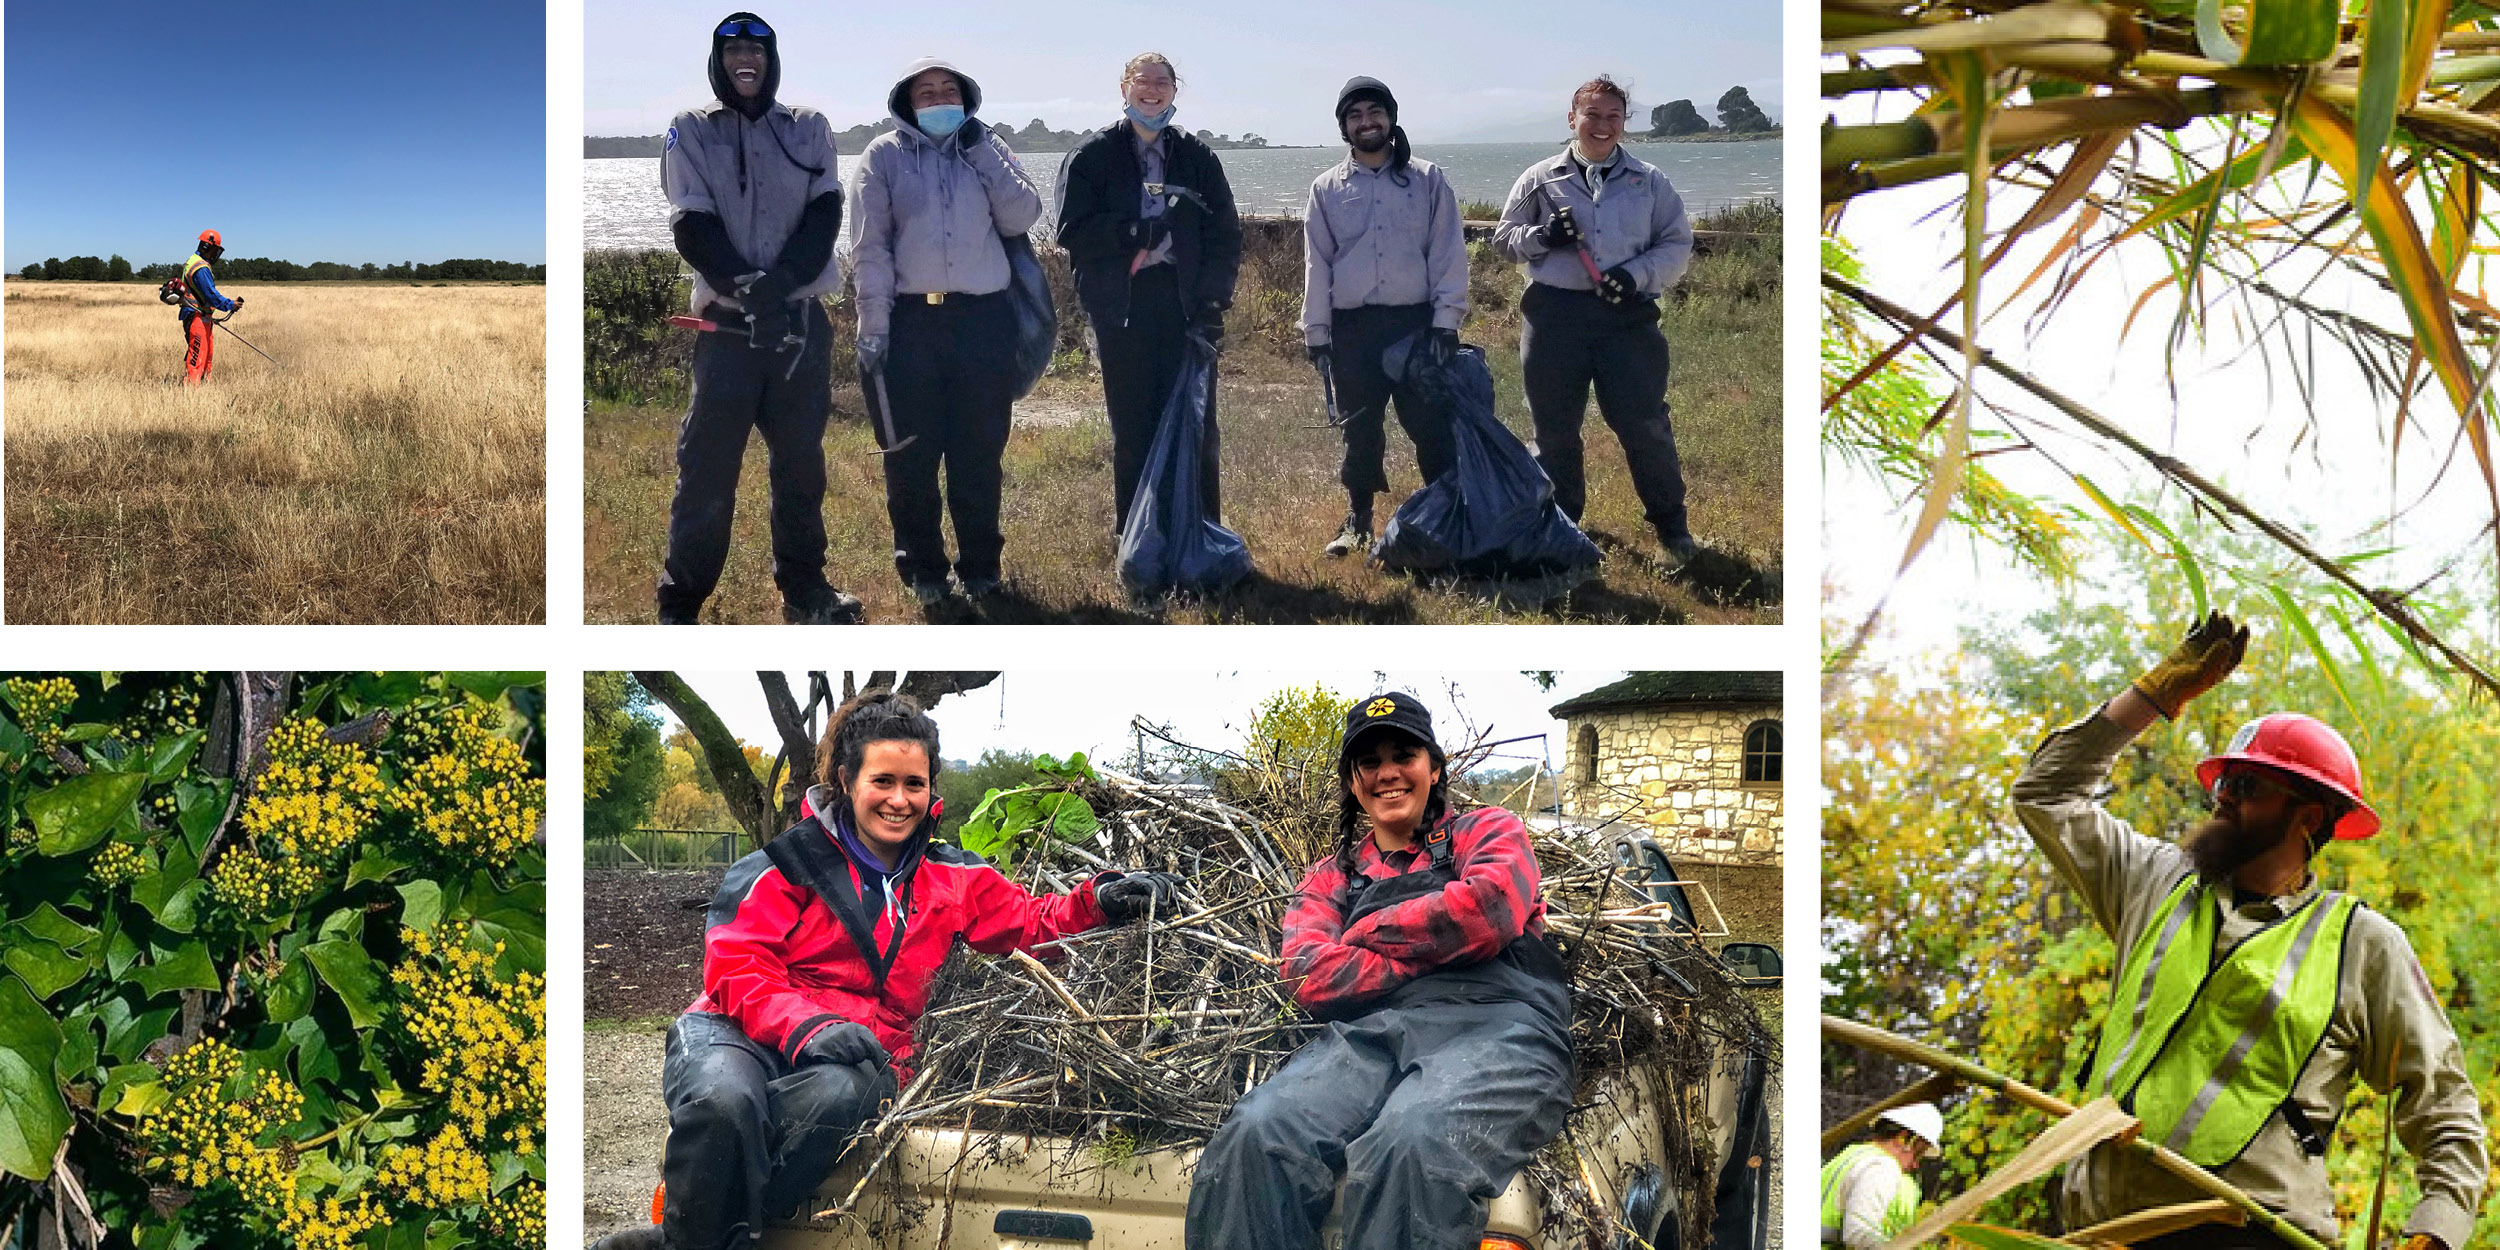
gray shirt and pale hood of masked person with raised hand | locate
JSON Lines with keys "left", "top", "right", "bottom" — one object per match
{"left": 850, "top": 58, "right": 1043, "bottom": 335}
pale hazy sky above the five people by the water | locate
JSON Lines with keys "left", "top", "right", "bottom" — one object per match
{"left": 583, "top": 0, "right": 1780, "bottom": 145}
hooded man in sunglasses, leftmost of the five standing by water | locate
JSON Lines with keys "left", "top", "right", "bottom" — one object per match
{"left": 655, "top": 13, "right": 860, "bottom": 625}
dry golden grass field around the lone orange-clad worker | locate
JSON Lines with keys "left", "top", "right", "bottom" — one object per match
{"left": 5, "top": 278, "right": 548, "bottom": 625}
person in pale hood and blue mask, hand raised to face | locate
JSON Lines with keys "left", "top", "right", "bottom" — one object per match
{"left": 853, "top": 58, "right": 1043, "bottom": 608}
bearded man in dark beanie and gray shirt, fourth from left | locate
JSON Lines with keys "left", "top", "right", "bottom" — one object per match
{"left": 1303, "top": 78, "right": 1468, "bottom": 558}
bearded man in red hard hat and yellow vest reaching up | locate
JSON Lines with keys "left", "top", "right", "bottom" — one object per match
{"left": 2013, "top": 613, "right": 2490, "bottom": 1250}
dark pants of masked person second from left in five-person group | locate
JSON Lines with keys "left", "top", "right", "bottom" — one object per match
{"left": 885, "top": 293, "right": 1015, "bottom": 585}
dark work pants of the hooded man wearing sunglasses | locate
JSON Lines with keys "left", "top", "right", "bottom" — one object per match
{"left": 658, "top": 300, "right": 833, "bottom": 613}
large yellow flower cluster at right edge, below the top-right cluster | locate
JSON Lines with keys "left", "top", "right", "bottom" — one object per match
{"left": 390, "top": 930, "right": 548, "bottom": 1155}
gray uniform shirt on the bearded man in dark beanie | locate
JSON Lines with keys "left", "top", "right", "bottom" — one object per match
{"left": 1303, "top": 158, "right": 1468, "bottom": 345}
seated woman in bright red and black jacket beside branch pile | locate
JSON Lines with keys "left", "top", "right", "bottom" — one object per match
{"left": 598, "top": 693, "right": 1180, "bottom": 1250}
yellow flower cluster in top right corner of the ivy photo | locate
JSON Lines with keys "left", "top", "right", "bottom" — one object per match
{"left": 390, "top": 708, "right": 548, "bottom": 868}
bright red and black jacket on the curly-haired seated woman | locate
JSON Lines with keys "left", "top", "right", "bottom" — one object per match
{"left": 688, "top": 785, "right": 1105, "bottom": 1083}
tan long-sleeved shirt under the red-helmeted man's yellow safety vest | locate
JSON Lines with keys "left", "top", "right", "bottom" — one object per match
{"left": 2013, "top": 713, "right": 2488, "bottom": 1250}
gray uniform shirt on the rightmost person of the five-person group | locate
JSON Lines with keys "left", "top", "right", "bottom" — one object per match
{"left": 1493, "top": 148, "right": 1693, "bottom": 295}
